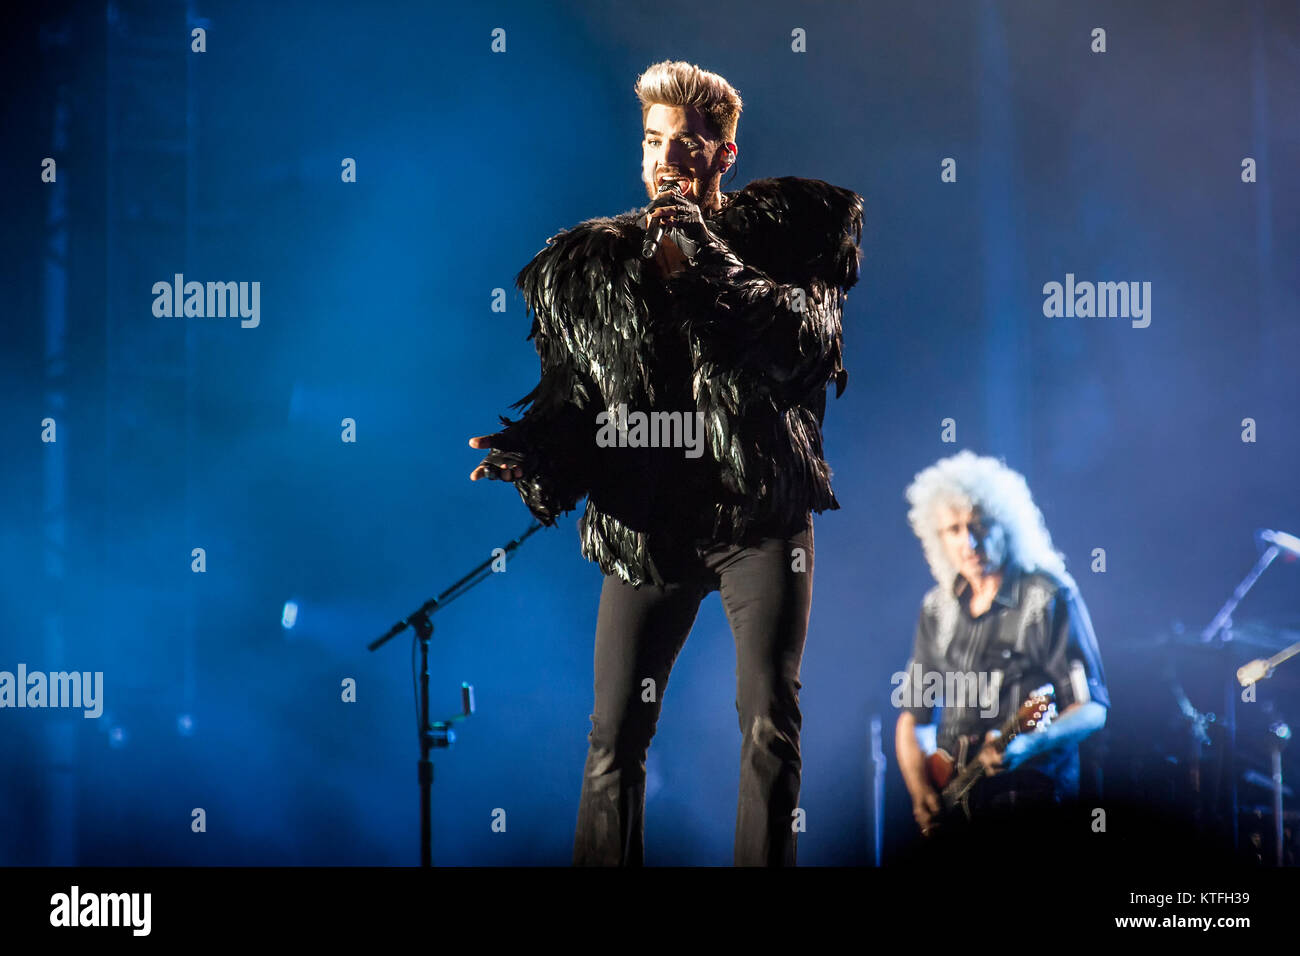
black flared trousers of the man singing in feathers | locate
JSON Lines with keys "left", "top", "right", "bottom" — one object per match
{"left": 573, "top": 515, "right": 813, "bottom": 866}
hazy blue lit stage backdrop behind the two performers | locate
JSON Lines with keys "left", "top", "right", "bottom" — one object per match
{"left": 0, "top": 0, "right": 1300, "bottom": 865}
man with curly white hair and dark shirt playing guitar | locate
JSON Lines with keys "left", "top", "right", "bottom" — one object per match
{"left": 894, "top": 451, "right": 1110, "bottom": 836}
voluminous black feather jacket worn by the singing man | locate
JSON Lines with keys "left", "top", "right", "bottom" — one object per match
{"left": 484, "top": 177, "right": 862, "bottom": 587}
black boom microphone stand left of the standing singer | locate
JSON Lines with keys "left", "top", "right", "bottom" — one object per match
{"left": 365, "top": 522, "right": 542, "bottom": 866}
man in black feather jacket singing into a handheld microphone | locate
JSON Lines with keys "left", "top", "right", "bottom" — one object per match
{"left": 469, "top": 62, "right": 862, "bottom": 865}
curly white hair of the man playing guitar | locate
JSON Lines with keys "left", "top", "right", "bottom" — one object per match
{"left": 906, "top": 450, "right": 1070, "bottom": 588}
